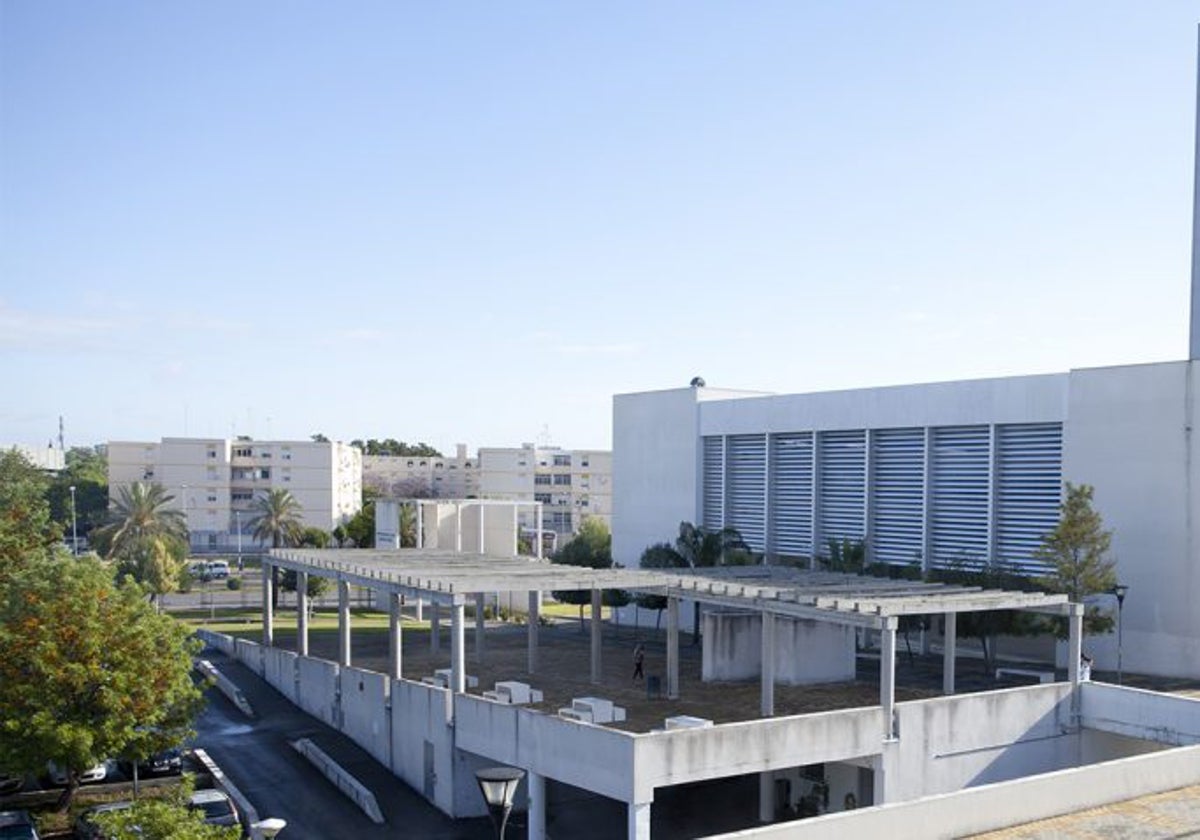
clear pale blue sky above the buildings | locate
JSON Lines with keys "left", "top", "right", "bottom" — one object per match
{"left": 0, "top": 0, "right": 1200, "bottom": 449}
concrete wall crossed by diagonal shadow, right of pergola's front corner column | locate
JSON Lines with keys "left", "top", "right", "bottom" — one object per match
{"left": 881, "top": 683, "right": 1080, "bottom": 802}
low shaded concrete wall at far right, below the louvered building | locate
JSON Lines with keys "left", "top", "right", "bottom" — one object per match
{"left": 1080, "top": 683, "right": 1200, "bottom": 746}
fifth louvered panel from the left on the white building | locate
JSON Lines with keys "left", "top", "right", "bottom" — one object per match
{"left": 870, "top": 428, "right": 925, "bottom": 564}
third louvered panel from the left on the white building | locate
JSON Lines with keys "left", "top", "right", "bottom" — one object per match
{"left": 770, "top": 432, "right": 812, "bottom": 559}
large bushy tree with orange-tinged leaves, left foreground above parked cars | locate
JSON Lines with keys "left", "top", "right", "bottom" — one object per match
{"left": 0, "top": 558, "right": 203, "bottom": 810}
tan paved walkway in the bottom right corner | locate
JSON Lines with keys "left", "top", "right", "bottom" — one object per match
{"left": 974, "top": 786, "right": 1200, "bottom": 840}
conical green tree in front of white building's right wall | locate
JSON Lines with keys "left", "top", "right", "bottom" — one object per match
{"left": 1033, "top": 481, "right": 1117, "bottom": 634}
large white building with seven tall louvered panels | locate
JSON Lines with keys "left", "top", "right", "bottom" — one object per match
{"left": 613, "top": 361, "right": 1200, "bottom": 678}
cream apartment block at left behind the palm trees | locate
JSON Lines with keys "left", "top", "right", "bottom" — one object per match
{"left": 108, "top": 438, "right": 362, "bottom": 551}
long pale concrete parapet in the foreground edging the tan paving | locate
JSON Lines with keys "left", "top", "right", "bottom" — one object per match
{"left": 719, "top": 746, "right": 1200, "bottom": 840}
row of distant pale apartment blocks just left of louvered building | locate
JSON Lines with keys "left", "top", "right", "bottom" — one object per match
{"left": 362, "top": 443, "right": 612, "bottom": 534}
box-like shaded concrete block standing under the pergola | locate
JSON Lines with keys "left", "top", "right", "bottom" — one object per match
{"left": 702, "top": 612, "right": 856, "bottom": 685}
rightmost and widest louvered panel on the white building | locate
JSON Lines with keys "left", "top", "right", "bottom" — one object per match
{"left": 995, "top": 422, "right": 1062, "bottom": 574}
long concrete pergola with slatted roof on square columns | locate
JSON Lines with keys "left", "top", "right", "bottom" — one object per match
{"left": 263, "top": 548, "right": 1084, "bottom": 737}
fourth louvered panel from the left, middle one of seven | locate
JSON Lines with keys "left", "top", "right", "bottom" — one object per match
{"left": 817, "top": 430, "right": 866, "bottom": 553}
